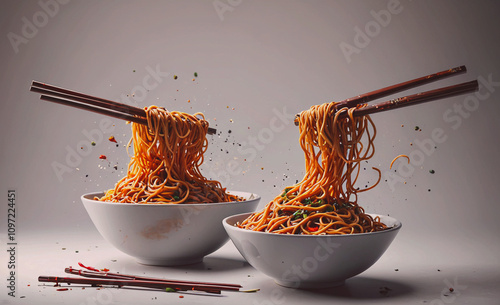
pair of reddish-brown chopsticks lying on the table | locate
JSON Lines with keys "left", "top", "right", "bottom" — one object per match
{"left": 38, "top": 267, "right": 252, "bottom": 294}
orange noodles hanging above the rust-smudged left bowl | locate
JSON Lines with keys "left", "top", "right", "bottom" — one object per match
{"left": 99, "top": 106, "right": 241, "bottom": 203}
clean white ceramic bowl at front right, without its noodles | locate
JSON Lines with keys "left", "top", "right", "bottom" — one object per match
{"left": 223, "top": 213, "right": 401, "bottom": 288}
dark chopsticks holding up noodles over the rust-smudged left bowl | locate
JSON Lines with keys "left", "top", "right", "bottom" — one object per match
{"left": 30, "top": 81, "right": 217, "bottom": 134}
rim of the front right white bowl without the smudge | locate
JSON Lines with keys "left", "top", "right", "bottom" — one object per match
{"left": 222, "top": 212, "right": 403, "bottom": 238}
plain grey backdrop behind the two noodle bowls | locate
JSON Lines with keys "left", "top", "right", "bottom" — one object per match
{"left": 0, "top": 0, "right": 500, "bottom": 304}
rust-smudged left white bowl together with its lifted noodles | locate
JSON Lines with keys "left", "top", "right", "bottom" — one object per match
{"left": 81, "top": 106, "right": 260, "bottom": 265}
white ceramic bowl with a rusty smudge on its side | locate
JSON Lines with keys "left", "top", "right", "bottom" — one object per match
{"left": 82, "top": 192, "right": 260, "bottom": 265}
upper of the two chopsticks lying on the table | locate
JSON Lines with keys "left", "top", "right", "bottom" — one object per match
{"left": 64, "top": 267, "right": 242, "bottom": 291}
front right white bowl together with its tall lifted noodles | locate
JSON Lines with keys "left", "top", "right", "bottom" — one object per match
{"left": 223, "top": 102, "right": 401, "bottom": 288}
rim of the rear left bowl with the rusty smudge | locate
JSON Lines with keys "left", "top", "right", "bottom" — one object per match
{"left": 80, "top": 190, "right": 261, "bottom": 208}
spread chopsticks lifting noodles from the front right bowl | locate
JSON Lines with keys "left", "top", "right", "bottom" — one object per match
{"left": 295, "top": 66, "right": 479, "bottom": 125}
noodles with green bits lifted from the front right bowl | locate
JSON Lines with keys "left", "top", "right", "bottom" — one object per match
{"left": 237, "top": 103, "right": 386, "bottom": 235}
